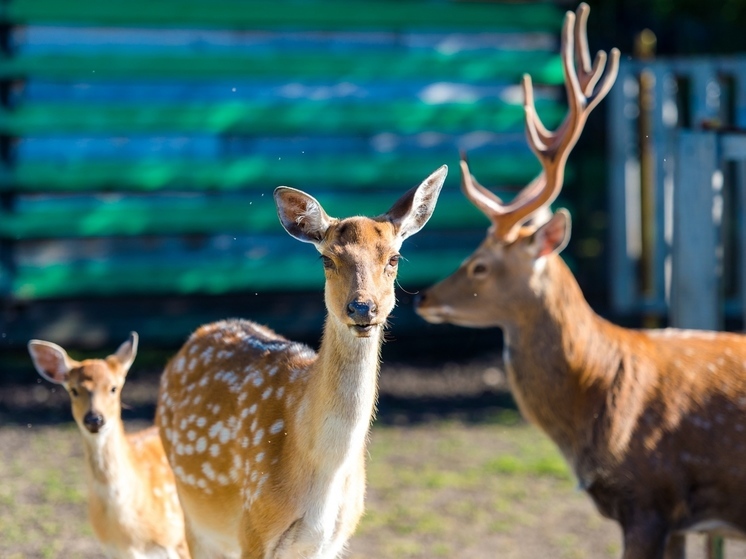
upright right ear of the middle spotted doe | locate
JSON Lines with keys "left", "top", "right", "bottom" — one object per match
{"left": 386, "top": 165, "right": 448, "bottom": 240}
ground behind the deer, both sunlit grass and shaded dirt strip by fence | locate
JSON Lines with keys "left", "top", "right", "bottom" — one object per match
{"left": 0, "top": 355, "right": 746, "bottom": 559}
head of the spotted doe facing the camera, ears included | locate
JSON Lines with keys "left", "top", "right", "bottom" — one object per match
{"left": 275, "top": 162, "right": 448, "bottom": 338}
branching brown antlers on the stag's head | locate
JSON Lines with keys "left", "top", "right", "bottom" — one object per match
{"left": 461, "top": 3, "right": 619, "bottom": 241}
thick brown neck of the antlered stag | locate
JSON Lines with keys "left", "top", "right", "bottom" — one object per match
{"left": 504, "top": 255, "right": 620, "bottom": 458}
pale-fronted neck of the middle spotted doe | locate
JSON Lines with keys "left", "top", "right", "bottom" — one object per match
{"left": 298, "top": 317, "right": 382, "bottom": 471}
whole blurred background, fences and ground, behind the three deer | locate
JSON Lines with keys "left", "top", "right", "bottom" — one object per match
{"left": 0, "top": 0, "right": 746, "bottom": 559}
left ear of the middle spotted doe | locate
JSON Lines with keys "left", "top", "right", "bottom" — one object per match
{"left": 275, "top": 186, "right": 333, "bottom": 244}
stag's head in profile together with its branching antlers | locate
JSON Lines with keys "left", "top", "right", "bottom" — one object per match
{"left": 417, "top": 3, "right": 619, "bottom": 327}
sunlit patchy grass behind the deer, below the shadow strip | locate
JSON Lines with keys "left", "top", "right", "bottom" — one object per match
{"left": 0, "top": 418, "right": 619, "bottom": 559}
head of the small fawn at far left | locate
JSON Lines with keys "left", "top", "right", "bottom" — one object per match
{"left": 28, "top": 332, "right": 137, "bottom": 434}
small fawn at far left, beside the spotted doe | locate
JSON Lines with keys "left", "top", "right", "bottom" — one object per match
{"left": 28, "top": 332, "right": 189, "bottom": 559}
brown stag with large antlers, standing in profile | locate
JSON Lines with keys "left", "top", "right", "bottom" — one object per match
{"left": 417, "top": 4, "right": 746, "bottom": 559}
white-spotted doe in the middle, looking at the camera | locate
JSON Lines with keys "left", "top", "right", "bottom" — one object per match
{"left": 156, "top": 167, "right": 446, "bottom": 559}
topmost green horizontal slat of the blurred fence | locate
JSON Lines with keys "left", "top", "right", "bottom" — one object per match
{"left": 0, "top": 0, "right": 561, "bottom": 30}
